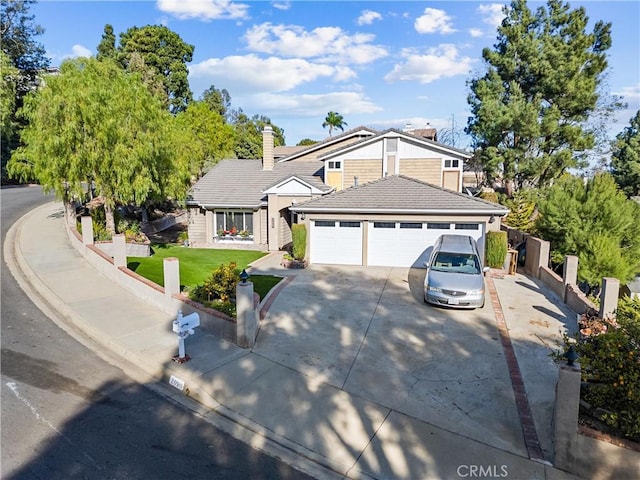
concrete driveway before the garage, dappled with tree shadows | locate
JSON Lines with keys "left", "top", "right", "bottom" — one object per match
{"left": 254, "top": 265, "right": 527, "bottom": 456}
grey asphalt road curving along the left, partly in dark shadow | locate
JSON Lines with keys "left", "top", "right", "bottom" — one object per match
{"left": 0, "top": 187, "right": 312, "bottom": 480}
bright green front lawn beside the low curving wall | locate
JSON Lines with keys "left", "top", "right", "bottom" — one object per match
{"left": 127, "top": 244, "right": 282, "bottom": 298}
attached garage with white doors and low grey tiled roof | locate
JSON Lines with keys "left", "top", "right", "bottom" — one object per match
{"left": 291, "top": 175, "right": 509, "bottom": 268}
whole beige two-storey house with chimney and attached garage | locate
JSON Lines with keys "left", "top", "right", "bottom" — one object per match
{"left": 187, "top": 126, "right": 508, "bottom": 266}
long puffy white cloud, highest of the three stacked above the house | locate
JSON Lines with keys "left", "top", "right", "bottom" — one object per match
{"left": 244, "top": 22, "right": 388, "bottom": 64}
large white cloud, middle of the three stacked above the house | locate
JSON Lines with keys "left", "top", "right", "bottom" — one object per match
{"left": 189, "top": 55, "right": 355, "bottom": 95}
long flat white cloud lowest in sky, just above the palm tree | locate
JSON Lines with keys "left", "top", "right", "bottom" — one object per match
{"left": 239, "top": 92, "right": 382, "bottom": 118}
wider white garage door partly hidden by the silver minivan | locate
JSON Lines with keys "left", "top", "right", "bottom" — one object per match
{"left": 367, "top": 222, "right": 484, "bottom": 267}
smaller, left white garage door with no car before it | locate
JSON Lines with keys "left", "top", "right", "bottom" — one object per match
{"left": 309, "top": 220, "right": 362, "bottom": 265}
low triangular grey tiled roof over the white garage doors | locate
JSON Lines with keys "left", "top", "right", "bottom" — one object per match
{"left": 291, "top": 175, "right": 509, "bottom": 216}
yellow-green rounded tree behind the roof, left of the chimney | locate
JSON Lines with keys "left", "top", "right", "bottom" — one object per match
{"left": 175, "top": 101, "right": 235, "bottom": 177}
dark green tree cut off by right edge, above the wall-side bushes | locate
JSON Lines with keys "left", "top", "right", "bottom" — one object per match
{"left": 611, "top": 110, "right": 640, "bottom": 197}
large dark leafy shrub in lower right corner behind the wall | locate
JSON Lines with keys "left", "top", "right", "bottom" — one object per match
{"left": 564, "top": 298, "right": 640, "bottom": 441}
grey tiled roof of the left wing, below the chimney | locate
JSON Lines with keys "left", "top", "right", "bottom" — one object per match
{"left": 187, "top": 159, "right": 332, "bottom": 208}
